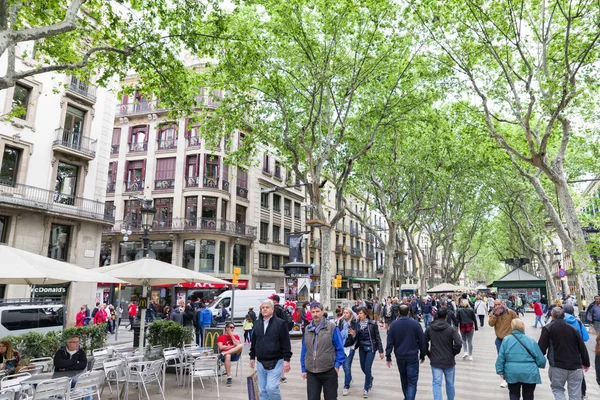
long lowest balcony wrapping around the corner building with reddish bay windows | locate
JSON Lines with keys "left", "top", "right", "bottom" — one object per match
{"left": 104, "top": 217, "right": 257, "bottom": 240}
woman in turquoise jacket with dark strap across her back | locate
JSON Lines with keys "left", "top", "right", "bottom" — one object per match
{"left": 496, "top": 318, "right": 546, "bottom": 400}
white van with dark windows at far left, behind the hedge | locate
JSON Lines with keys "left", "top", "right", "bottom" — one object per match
{"left": 0, "top": 303, "right": 65, "bottom": 338}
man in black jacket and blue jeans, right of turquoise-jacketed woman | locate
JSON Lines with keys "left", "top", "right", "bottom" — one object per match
{"left": 538, "top": 307, "right": 590, "bottom": 400}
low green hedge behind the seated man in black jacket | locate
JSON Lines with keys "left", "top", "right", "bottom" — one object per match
{"left": 3, "top": 324, "right": 107, "bottom": 359}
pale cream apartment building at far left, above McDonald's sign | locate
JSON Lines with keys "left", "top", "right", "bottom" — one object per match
{"left": 0, "top": 45, "right": 115, "bottom": 315}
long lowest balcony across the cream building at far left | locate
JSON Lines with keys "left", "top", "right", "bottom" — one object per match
{"left": 0, "top": 182, "right": 114, "bottom": 221}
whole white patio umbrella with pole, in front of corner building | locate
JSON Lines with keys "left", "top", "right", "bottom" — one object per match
{"left": 100, "top": 257, "right": 231, "bottom": 351}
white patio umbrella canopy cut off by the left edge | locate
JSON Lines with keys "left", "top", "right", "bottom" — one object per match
{"left": 0, "top": 244, "right": 127, "bottom": 286}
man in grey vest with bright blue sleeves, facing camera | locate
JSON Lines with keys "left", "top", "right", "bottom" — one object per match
{"left": 300, "top": 303, "right": 346, "bottom": 400}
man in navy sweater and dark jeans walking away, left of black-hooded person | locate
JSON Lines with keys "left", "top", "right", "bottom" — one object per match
{"left": 385, "top": 305, "right": 426, "bottom": 400}
